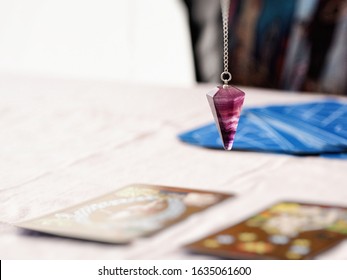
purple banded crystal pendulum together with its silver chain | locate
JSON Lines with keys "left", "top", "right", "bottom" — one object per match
{"left": 207, "top": 0, "right": 245, "bottom": 150}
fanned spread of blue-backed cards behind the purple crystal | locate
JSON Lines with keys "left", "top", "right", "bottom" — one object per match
{"left": 179, "top": 100, "right": 347, "bottom": 159}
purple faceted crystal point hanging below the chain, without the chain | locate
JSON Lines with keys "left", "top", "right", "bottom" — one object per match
{"left": 207, "top": 85, "right": 245, "bottom": 150}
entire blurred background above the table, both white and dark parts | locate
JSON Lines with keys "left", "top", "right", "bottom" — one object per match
{"left": 0, "top": 0, "right": 347, "bottom": 95}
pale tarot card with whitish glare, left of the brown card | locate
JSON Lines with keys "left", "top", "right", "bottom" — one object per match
{"left": 17, "top": 184, "right": 231, "bottom": 243}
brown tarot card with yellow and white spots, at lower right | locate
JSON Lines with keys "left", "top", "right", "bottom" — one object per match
{"left": 186, "top": 202, "right": 347, "bottom": 260}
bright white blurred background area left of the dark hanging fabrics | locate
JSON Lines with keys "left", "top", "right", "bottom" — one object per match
{"left": 0, "top": 0, "right": 194, "bottom": 86}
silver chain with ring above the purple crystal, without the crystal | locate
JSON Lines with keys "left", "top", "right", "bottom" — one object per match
{"left": 220, "top": 0, "right": 232, "bottom": 85}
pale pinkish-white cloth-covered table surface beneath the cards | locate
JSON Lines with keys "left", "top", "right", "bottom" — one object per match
{"left": 0, "top": 74, "right": 347, "bottom": 259}
